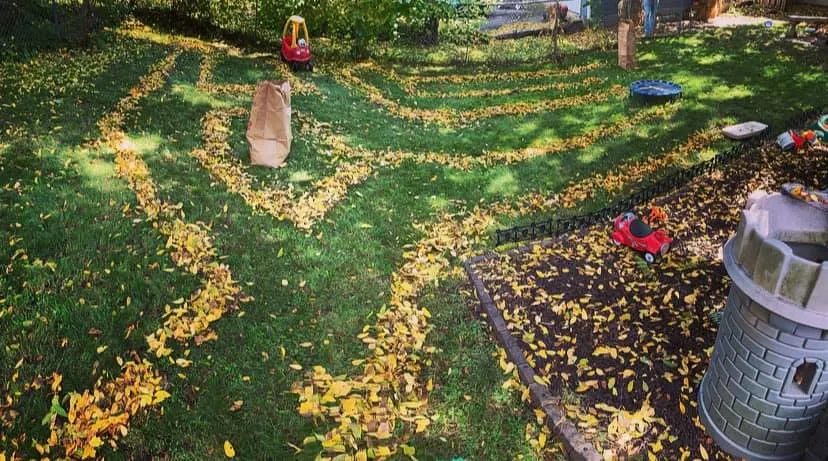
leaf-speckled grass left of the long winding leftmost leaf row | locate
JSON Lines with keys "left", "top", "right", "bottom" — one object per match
{"left": 0, "top": 37, "right": 193, "bottom": 449}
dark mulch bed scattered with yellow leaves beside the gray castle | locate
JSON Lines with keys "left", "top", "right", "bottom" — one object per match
{"left": 475, "top": 138, "right": 828, "bottom": 460}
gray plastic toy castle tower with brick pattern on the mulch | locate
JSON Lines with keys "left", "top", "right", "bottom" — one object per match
{"left": 699, "top": 192, "right": 828, "bottom": 460}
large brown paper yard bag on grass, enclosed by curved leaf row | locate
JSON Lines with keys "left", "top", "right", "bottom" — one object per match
{"left": 247, "top": 80, "right": 293, "bottom": 168}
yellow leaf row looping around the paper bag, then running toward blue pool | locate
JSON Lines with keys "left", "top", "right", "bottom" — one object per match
{"left": 192, "top": 50, "right": 678, "bottom": 237}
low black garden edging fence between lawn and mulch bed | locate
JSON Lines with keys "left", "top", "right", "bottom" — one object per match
{"left": 495, "top": 108, "right": 823, "bottom": 246}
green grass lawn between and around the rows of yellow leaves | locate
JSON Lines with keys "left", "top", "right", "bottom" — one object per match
{"left": 0, "top": 22, "right": 828, "bottom": 460}
